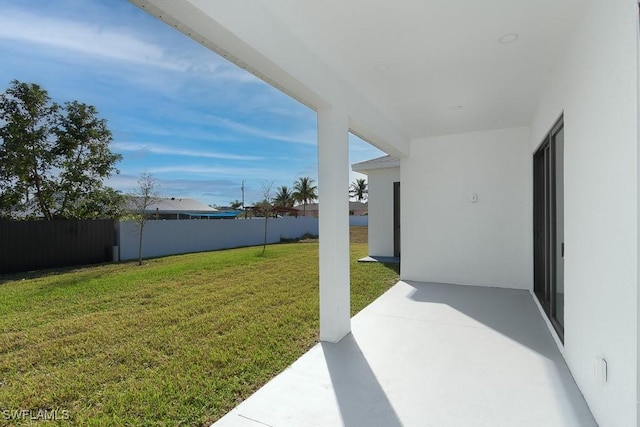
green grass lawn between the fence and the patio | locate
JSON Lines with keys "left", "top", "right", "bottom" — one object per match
{"left": 0, "top": 243, "right": 398, "bottom": 426}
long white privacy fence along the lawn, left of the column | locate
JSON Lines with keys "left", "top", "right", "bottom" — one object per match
{"left": 118, "top": 217, "right": 318, "bottom": 261}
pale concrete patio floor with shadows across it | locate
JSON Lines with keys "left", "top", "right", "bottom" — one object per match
{"left": 214, "top": 282, "right": 597, "bottom": 427}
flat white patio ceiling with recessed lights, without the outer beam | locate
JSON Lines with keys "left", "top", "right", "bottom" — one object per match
{"left": 264, "top": 0, "right": 581, "bottom": 138}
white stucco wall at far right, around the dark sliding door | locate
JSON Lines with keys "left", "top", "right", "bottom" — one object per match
{"left": 530, "top": 0, "right": 639, "bottom": 427}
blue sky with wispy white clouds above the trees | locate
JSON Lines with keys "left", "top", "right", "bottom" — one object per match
{"left": 0, "top": 0, "right": 384, "bottom": 205}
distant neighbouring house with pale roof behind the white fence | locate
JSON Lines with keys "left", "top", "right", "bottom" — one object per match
{"left": 127, "top": 197, "right": 220, "bottom": 219}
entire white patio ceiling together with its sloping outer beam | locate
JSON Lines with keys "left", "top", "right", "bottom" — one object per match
{"left": 132, "top": 0, "right": 581, "bottom": 144}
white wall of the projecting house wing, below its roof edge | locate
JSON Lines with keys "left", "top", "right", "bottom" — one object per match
{"left": 367, "top": 167, "right": 402, "bottom": 256}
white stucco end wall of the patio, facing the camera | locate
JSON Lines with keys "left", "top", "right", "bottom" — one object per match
{"left": 401, "top": 127, "right": 533, "bottom": 289}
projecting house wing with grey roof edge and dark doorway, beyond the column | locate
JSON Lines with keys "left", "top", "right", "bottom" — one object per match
{"left": 351, "top": 156, "right": 400, "bottom": 257}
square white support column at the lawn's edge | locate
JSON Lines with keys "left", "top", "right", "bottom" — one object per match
{"left": 318, "top": 108, "right": 351, "bottom": 342}
